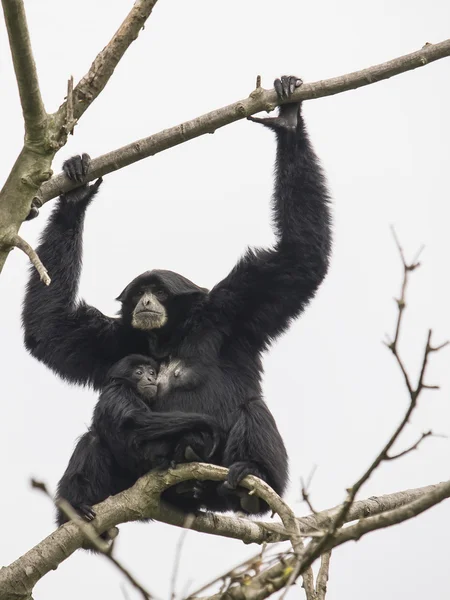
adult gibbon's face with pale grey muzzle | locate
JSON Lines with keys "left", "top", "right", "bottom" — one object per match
{"left": 131, "top": 284, "right": 169, "bottom": 331}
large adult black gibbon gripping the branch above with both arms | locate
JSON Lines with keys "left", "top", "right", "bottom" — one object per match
{"left": 23, "top": 77, "right": 331, "bottom": 513}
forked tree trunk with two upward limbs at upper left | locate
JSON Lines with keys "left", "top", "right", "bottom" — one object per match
{"left": 0, "top": 0, "right": 157, "bottom": 272}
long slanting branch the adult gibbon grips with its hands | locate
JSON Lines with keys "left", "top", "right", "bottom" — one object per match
{"left": 38, "top": 40, "right": 450, "bottom": 203}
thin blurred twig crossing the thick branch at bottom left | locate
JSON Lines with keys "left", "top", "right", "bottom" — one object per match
{"left": 31, "top": 479, "right": 153, "bottom": 600}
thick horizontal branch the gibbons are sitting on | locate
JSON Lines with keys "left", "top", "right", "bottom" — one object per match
{"left": 0, "top": 463, "right": 450, "bottom": 600}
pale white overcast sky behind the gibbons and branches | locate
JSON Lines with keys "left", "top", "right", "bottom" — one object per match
{"left": 0, "top": 0, "right": 450, "bottom": 600}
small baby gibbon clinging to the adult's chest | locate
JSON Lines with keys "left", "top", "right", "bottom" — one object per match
{"left": 57, "top": 354, "right": 221, "bottom": 525}
